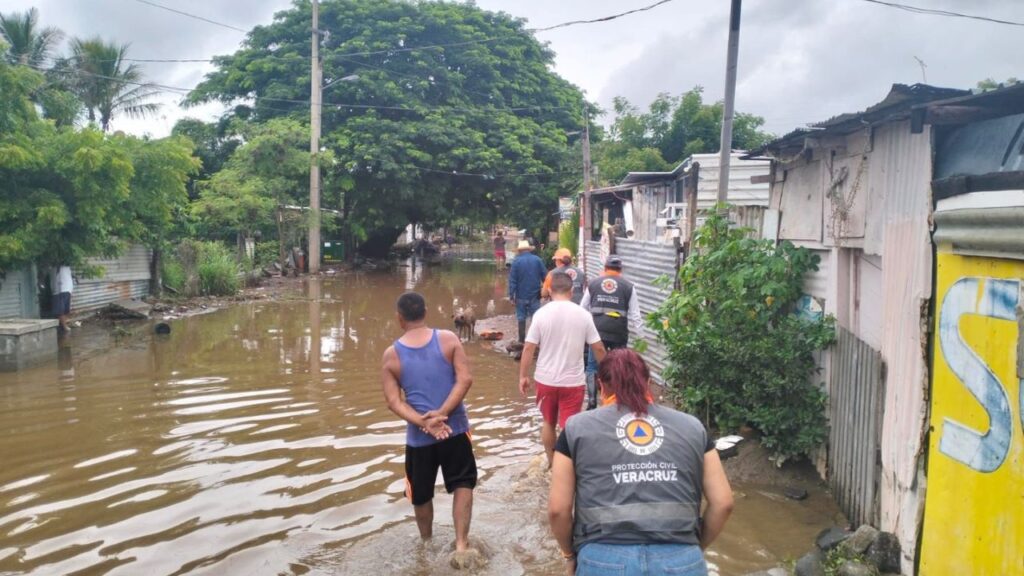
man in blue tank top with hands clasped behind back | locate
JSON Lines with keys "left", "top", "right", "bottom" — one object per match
{"left": 382, "top": 292, "right": 476, "bottom": 552}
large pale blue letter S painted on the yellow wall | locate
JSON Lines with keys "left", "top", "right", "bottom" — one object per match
{"left": 939, "top": 278, "right": 1024, "bottom": 472}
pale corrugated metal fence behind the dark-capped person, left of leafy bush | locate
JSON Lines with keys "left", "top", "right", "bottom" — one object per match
{"left": 584, "top": 238, "right": 677, "bottom": 382}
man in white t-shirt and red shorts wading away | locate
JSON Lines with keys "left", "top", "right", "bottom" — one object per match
{"left": 519, "top": 271, "right": 604, "bottom": 466}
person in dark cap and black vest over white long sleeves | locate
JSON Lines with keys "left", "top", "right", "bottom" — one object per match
{"left": 580, "top": 256, "right": 643, "bottom": 409}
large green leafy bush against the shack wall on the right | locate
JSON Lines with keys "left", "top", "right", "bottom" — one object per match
{"left": 648, "top": 206, "right": 835, "bottom": 463}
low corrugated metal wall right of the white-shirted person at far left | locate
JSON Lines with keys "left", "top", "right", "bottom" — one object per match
{"left": 71, "top": 246, "right": 152, "bottom": 314}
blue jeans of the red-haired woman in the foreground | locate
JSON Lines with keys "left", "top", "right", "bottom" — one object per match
{"left": 577, "top": 542, "right": 708, "bottom": 576}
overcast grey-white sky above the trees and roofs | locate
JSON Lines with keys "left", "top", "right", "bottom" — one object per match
{"left": 9, "top": 0, "right": 1024, "bottom": 136}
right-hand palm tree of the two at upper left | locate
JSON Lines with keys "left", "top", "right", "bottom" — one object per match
{"left": 71, "top": 37, "right": 160, "bottom": 131}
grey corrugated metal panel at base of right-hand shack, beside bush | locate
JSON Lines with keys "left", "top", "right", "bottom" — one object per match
{"left": 828, "top": 327, "right": 885, "bottom": 526}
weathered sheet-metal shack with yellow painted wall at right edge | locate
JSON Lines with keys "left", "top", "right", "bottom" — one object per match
{"left": 754, "top": 84, "right": 1024, "bottom": 574}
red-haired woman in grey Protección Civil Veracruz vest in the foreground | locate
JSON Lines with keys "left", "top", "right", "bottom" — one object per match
{"left": 548, "top": 349, "right": 733, "bottom": 576}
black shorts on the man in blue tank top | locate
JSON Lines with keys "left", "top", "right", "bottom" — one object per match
{"left": 406, "top": 434, "right": 476, "bottom": 506}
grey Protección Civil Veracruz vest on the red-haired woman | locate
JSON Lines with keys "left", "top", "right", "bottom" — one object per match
{"left": 565, "top": 404, "right": 708, "bottom": 550}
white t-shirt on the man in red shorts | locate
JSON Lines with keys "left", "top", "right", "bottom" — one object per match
{"left": 526, "top": 300, "right": 601, "bottom": 386}
